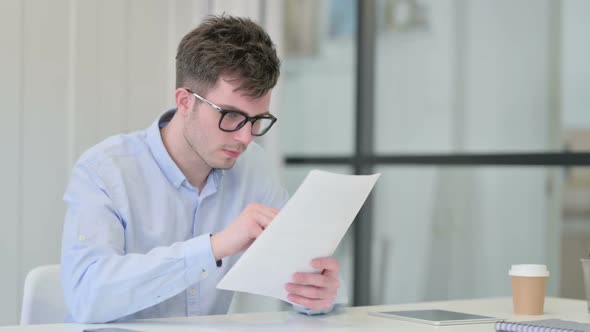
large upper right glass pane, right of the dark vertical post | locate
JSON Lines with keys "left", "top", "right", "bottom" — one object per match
{"left": 375, "top": 0, "right": 590, "bottom": 154}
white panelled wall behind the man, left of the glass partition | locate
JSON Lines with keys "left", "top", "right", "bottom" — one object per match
{"left": 0, "top": 0, "right": 280, "bottom": 325}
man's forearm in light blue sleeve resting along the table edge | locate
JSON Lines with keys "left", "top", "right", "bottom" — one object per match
{"left": 62, "top": 234, "right": 216, "bottom": 323}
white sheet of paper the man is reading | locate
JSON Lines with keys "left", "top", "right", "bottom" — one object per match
{"left": 217, "top": 170, "right": 380, "bottom": 302}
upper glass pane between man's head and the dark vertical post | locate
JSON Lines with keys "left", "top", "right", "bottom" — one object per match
{"left": 278, "top": 0, "right": 356, "bottom": 156}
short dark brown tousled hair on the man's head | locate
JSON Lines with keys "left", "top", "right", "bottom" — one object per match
{"left": 176, "top": 15, "right": 280, "bottom": 98}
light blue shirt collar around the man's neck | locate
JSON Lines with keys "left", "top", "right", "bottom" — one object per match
{"left": 147, "top": 108, "right": 225, "bottom": 191}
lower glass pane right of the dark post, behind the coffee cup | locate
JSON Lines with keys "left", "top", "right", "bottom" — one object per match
{"left": 371, "top": 166, "right": 572, "bottom": 304}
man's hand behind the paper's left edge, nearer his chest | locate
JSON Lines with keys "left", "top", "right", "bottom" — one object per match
{"left": 211, "top": 204, "right": 279, "bottom": 260}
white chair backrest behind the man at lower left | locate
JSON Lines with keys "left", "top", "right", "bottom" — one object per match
{"left": 20, "top": 265, "right": 66, "bottom": 325}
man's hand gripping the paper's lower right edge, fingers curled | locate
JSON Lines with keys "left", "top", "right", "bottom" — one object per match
{"left": 285, "top": 257, "right": 340, "bottom": 310}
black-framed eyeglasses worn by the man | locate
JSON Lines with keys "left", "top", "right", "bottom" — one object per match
{"left": 185, "top": 88, "right": 277, "bottom": 136}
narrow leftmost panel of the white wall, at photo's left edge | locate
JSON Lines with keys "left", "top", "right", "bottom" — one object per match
{"left": 0, "top": 0, "right": 23, "bottom": 324}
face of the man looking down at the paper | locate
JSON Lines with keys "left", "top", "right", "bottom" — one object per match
{"left": 183, "top": 77, "right": 271, "bottom": 169}
